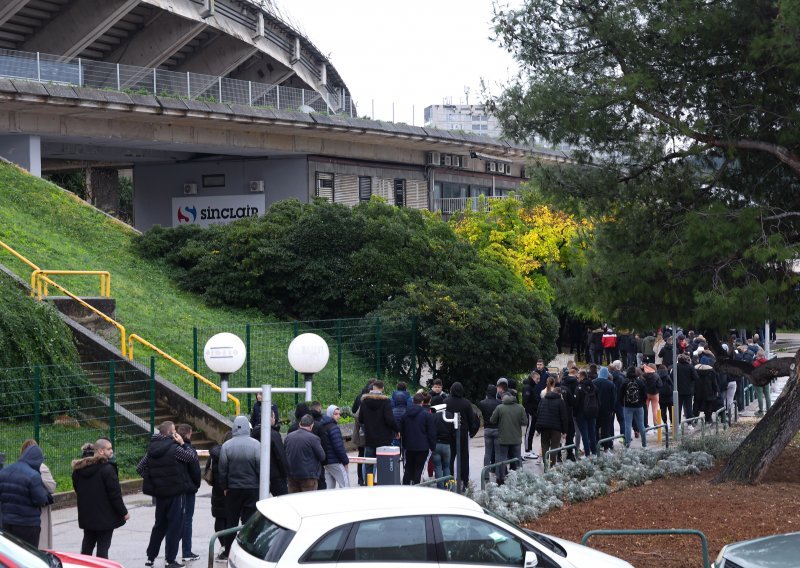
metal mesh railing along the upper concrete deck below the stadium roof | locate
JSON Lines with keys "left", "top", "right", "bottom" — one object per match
{"left": 0, "top": 49, "right": 356, "bottom": 117}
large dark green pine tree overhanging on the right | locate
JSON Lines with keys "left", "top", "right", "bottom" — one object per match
{"left": 493, "top": 0, "right": 800, "bottom": 481}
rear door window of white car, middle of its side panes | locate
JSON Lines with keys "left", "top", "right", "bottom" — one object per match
{"left": 351, "top": 517, "right": 429, "bottom": 562}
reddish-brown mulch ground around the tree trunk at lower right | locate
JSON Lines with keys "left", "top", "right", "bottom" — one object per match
{"left": 526, "top": 445, "right": 800, "bottom": 568}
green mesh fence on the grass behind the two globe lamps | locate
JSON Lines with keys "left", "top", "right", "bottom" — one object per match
{"left": 193, "top": 318, "right": 418, "bottom": 416}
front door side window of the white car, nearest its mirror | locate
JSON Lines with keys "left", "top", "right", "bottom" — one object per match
{"left": 437, "top": 515, "right": 525, "bottom": 566}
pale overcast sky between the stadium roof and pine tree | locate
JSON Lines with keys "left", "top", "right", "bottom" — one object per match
{"left": 274, "top": 0, "right": 517, "bottom": 126}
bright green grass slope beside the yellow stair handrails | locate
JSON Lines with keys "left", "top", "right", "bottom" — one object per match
{"left": 0, "top": 162, "right": 290, "bottom": 415}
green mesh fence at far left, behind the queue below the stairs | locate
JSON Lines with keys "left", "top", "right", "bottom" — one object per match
{"left": 0, "top": 361, "right": 155, "bottom": 491}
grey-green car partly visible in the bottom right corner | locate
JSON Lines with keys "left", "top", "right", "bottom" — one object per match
{"left": 714, "top": 532, "right": 800, "bottom": 568}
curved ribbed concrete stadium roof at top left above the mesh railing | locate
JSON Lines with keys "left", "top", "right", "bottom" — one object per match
{"left": 0, "top": 0, "right": 350, "bottom": 105}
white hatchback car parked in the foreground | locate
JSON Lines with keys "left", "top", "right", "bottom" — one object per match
{"left": 228, "top": 486, "right": 631, "bottom": 568}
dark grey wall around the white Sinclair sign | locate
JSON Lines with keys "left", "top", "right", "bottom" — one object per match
{"left": 133, "top": 155, "right": 311, "bottom": 231}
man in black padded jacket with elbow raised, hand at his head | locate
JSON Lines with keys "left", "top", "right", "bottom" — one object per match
{"left": 136, "top": 418, "right": 200, "bottom": 568}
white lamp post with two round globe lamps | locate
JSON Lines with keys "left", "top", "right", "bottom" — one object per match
{"left": 209, "top": 333, "right": 330, "bottom": 499}
